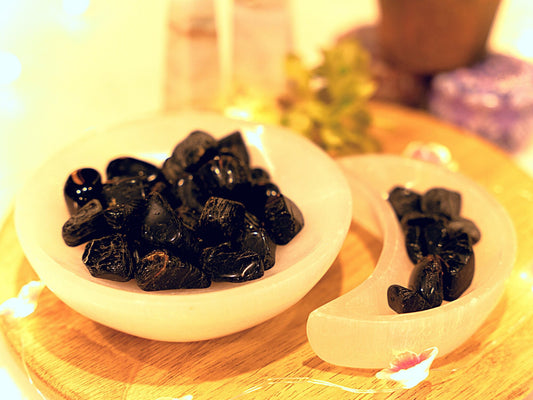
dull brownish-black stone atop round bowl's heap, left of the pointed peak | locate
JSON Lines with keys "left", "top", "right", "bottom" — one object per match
{"left": 172, "top": 130, "right": 218, "bottom": 172}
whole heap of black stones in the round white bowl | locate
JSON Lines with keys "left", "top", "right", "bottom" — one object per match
{"left": 62, "top": 130, "right": 304, "bottom": 291}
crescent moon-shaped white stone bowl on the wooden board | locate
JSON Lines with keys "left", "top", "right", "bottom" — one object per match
{"left": 307, "top": 155, "right": 516, "bottom": 368}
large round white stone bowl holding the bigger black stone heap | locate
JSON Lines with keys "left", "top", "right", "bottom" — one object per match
{"left": 15, "top": 112, "right": 352, "bottom": 341}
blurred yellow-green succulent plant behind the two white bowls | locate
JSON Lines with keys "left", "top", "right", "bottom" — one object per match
{"left": 279, "top": 40, "right": 378, "bottom": 154}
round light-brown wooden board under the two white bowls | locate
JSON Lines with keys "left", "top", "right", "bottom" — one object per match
{"left": 0, "top": 104, "right": 533, "bottom": 400}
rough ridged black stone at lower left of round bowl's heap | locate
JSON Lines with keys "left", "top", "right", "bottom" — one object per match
{"left": 82, "top": 234, "right": 133, "bottom": 282}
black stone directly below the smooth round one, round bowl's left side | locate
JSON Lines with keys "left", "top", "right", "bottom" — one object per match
{"left": 61, "top": 199, "right": 109, "bottom": 247}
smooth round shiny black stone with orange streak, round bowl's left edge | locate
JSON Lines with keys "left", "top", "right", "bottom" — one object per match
{"left": 63, "top": 168, "right": 102, "bottom": 215}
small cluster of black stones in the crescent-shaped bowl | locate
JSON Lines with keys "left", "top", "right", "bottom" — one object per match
{"left": 388, "top": 187, "right": 481, "bottom": 312}
